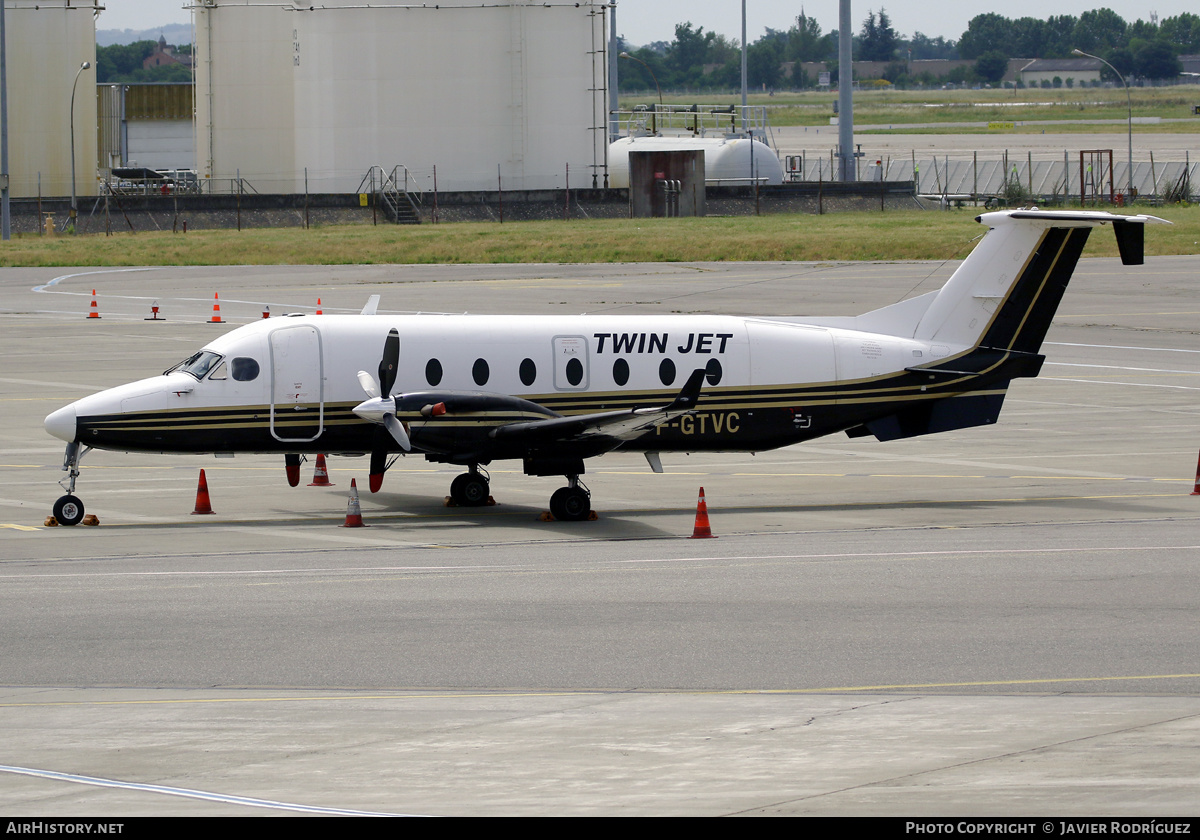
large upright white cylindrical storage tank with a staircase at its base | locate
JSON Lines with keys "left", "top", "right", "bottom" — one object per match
{"left": 194, "top": 0, "right": 607, "bottom": 192}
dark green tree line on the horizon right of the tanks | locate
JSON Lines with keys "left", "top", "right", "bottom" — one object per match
{"left": 619, "top": 8, "right": 1200, "bottom": 91}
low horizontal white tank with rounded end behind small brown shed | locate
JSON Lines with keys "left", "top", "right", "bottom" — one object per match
{"left": 608, "top": 137, "right": 784, "bottom": 188}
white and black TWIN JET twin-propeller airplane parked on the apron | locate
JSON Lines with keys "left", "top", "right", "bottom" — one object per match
{"left": 46, "top": 209, "right": 1163, "bottom": 524}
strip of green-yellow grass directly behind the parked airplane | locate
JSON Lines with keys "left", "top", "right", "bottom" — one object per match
{"left": 0, "top": 206, "right": 1200, "bottom": 268}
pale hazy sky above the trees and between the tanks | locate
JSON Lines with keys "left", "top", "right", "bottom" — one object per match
{"left": 96, "top": 0, "right": 1196, "bottom": 44}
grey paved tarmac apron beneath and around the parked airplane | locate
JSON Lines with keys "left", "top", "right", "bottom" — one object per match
{"left": 0, "top": 237, "right": 1200, "bottom": 816}
